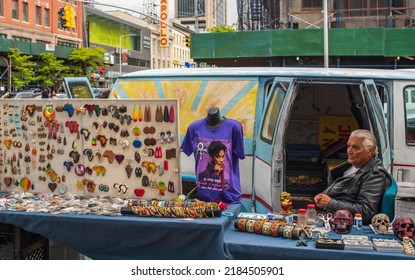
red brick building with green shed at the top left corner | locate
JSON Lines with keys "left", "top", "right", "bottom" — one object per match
{"left": 0, "top": 0, "right": 84, "bottom": 92}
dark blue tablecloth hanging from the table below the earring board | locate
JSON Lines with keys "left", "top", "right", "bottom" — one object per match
{"left": 0, "top": 205, "right": 240, "bottom": 260}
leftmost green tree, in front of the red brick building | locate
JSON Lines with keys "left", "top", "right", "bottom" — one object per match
{"left": 9, "top": 48, "right": 37, "bottom": 90}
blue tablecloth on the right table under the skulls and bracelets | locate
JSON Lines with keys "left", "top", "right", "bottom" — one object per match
{"left": 224, "top": 225, "right": 415, "bottom": 260}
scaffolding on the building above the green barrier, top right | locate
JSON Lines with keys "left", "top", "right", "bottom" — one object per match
{"left": 237, "top": 0, "right": 415, "bottom": 31}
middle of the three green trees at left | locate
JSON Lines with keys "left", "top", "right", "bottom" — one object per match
{"left": 36, "top": 53, "right": 70, "bottom": 87}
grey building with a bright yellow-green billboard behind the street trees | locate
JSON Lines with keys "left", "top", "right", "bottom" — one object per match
{"left": 85, "top": 7, "right": 151, "bottom": 87}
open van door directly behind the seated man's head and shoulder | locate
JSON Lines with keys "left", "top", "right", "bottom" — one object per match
{"left": 361, "top": 80, "right": 391, "bottom": 170}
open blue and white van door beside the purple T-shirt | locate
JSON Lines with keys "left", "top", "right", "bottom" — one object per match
{"left": 252, "top": 78, "right": 296, "bottom": 212}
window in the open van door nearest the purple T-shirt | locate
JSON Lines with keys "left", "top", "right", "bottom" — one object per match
{"left": 261, "top": 82, "right": 289, "bottom": 143}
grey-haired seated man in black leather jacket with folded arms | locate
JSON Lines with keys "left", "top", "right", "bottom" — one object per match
{"left": 314, "top": 129, "right": 391, "bottom": 224}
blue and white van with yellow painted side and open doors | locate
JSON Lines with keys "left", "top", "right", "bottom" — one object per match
{"left": 110, "top": 67, "right": 415, "bottom": 213}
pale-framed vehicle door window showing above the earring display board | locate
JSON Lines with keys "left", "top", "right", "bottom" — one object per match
{"left": 57, "top": 77, "right": 94, "bottom": 98}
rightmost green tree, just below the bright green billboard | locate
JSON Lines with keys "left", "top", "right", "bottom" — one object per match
{"left": 68, "top": 46, "right": 106, "bottom": 76}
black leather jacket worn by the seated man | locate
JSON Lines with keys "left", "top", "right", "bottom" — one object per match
{"left": 323, "top": 157, "right": 391, "bottom": 224}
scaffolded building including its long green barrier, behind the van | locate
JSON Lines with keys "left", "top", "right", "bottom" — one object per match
{"left": 191, "top": 0, "right": 415, "bottom": 69}
